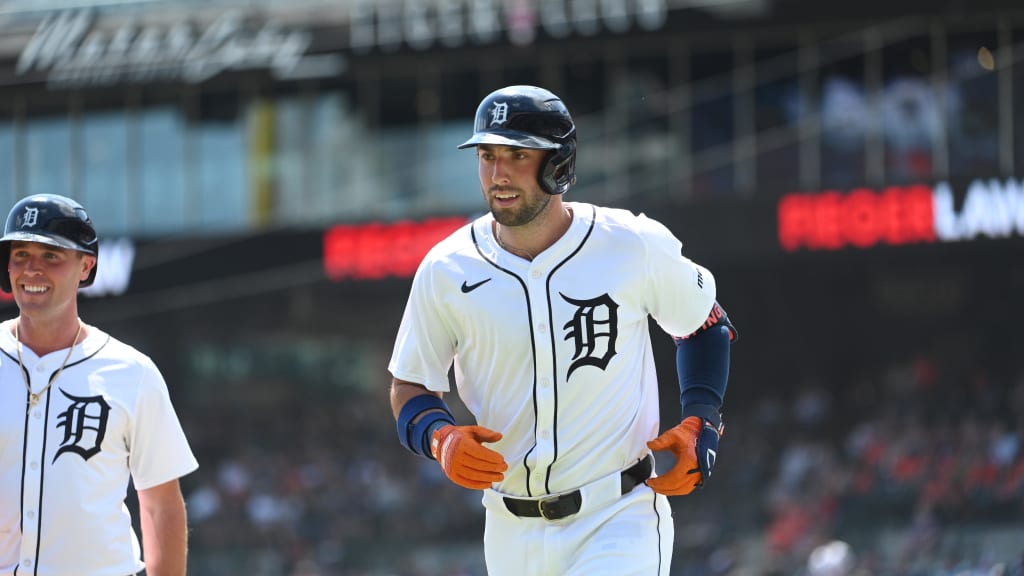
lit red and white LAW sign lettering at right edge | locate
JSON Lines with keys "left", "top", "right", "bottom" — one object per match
{"left": 777, "top": 179, "right": 1024, "bottom": 251}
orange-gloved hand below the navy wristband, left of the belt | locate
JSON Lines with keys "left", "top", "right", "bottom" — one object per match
{"left": 430, "top": 424, "right": 509, "bottom": 490}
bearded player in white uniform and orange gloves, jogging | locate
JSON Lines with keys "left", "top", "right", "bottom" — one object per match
{"left": 388, "top": 86, "right": 734, "bottom": 576}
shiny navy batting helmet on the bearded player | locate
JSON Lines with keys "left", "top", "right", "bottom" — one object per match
{"left": 459, "top": 86, "right": 577, "bottom": 194}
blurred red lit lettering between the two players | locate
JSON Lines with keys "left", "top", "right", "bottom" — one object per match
{"left": 324, "top": 216, "right": 467, "bottom": 281}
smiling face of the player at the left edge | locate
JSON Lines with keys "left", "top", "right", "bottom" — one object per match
{"left": 7, "top": 237, "right": 96, "bottom": 317}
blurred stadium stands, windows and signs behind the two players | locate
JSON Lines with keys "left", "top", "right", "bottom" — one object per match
{"left": 0, "top": 0, "right": 1024, "bottom": 576}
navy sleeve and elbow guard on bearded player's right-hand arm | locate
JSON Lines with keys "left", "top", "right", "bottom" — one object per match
{"left": 675, "top": 302, "right": 739, "bottom": 428}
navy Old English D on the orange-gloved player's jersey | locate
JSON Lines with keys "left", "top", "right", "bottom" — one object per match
{"left": 559, "top": 292, "right": 618, "bottom": 380}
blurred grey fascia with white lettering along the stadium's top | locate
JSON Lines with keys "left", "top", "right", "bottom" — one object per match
{"left": 0, "top": 0, "right": 772, "bottom": 89}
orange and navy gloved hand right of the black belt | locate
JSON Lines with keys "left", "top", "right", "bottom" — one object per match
{"left": 647, "top": 416, "right": 724, "bottom": 496}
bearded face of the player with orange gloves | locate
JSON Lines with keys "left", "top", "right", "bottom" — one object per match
{"left": 476, "top": 145, "right": 552, "bottom": 227}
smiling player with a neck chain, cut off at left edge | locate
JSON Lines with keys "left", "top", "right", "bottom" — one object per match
{"left": 0, "top": 194, "right": 198, "bottom": 576}
